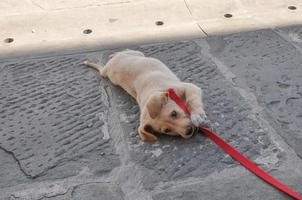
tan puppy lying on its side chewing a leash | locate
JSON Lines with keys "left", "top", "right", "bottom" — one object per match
{"left": 84, "top": 50, "right": 206, "bottom": 141}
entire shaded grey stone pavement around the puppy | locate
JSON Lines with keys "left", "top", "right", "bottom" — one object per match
{"left": 0, "top": 27, "right": 302, "bottom": 200}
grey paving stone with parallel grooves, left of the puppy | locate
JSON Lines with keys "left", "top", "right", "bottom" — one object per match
{"left": 0, "top": 55, "right": 119, "bottom": 178}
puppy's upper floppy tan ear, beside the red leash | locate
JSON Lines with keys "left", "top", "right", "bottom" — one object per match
{"left": 146, "top": 92, "right": 168, "bottom": 119}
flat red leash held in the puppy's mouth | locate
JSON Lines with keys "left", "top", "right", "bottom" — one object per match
{"left": 166, "top": 88, "right": 302, "bottom": 200}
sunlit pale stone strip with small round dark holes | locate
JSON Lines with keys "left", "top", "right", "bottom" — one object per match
{"left": 0, "top": 0, "right": 302, "bottom": 57}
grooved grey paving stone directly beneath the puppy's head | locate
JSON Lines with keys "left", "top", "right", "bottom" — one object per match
{"left": 105, "top": 42, "right": 279, "bottom": 190}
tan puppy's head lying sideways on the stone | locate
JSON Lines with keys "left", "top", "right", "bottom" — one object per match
{"left": 139, "top": 92, "right": 195, "bottom": 140}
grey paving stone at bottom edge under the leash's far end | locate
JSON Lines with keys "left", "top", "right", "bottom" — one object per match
{"left": 152, "top": 168, "right": 301, "bottom": 200}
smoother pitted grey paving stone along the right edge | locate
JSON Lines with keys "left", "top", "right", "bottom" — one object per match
{"left": 208, "top": 28, "right": 302, "bottom": 158}
